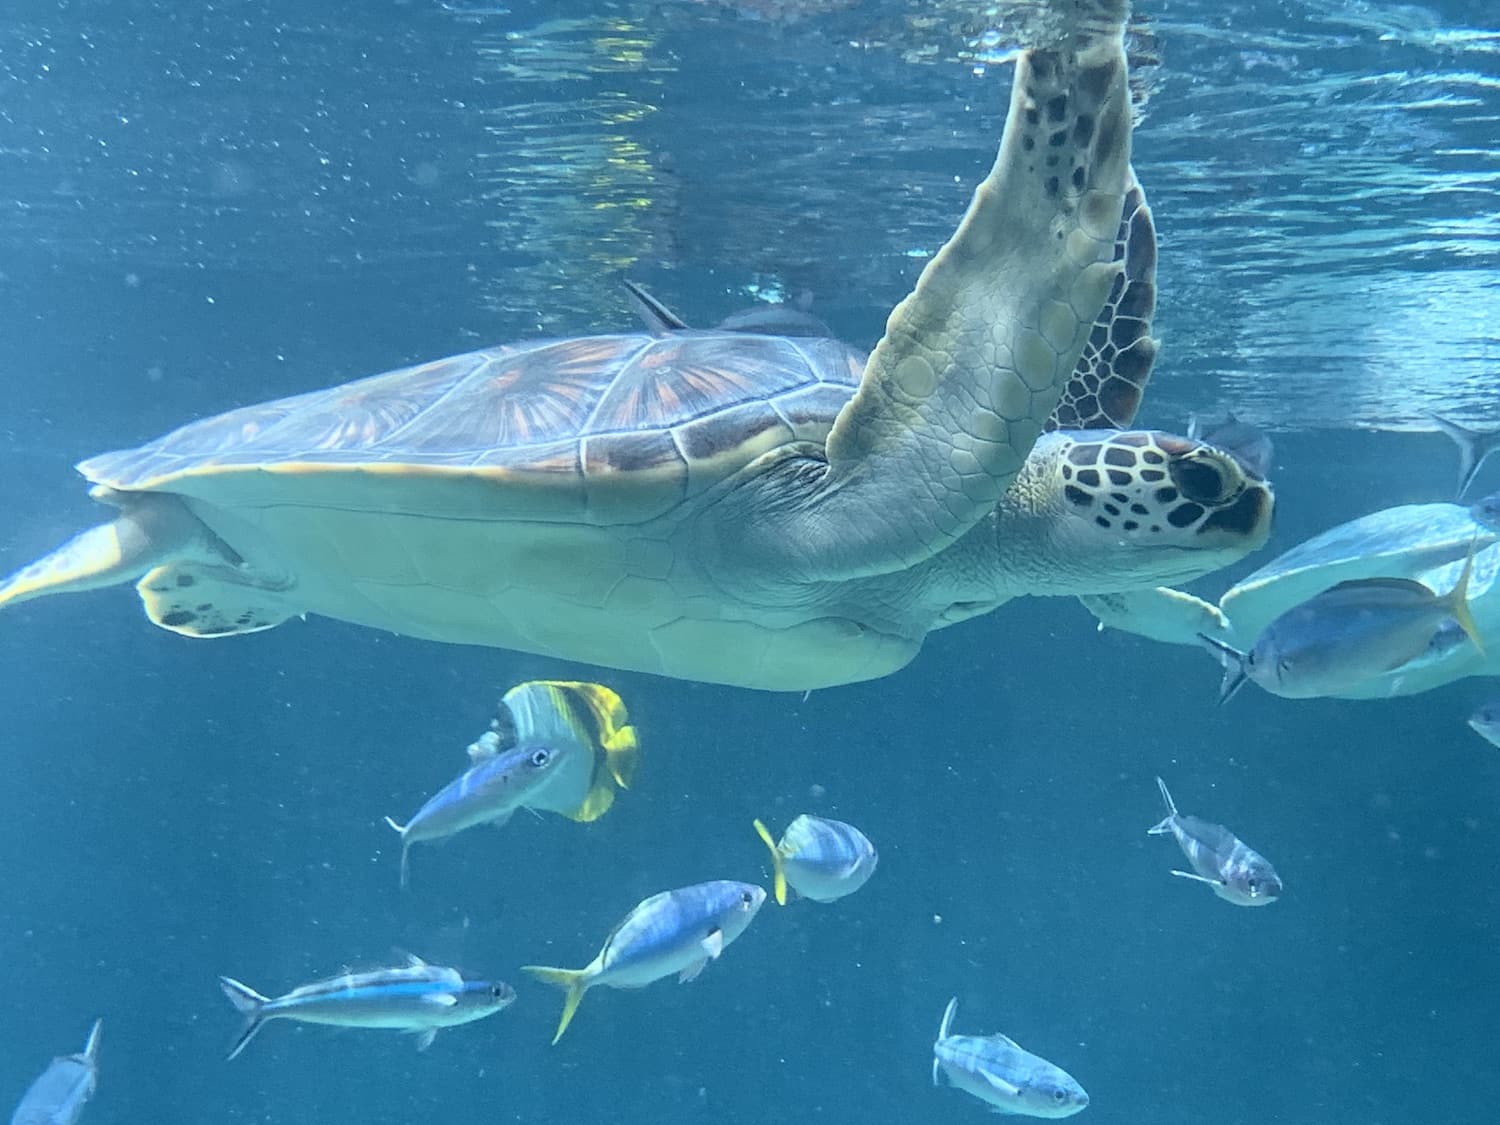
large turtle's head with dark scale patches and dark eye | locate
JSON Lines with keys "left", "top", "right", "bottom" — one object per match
{"left": 1028, "top": 431, "right": 1274, "bottom": 593}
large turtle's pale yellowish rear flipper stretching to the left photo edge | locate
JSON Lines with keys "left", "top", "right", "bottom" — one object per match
{"left": 0, "top": 486, "right": 215, "bottom": 609}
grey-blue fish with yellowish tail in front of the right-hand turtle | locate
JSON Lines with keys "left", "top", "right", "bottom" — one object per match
{"left": 1199, "top": 539, "right": 1485, "bottom": 704}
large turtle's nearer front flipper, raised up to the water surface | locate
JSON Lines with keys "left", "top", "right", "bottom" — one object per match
{"left": 797, "top": 0, "right": 1131, "bottom": 578}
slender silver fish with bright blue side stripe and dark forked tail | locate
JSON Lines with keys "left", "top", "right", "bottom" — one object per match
{"left": 219, "top": 954, "right": 516, "bottom": 1059}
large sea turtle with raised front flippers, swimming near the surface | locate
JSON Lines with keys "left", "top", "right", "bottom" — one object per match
{"left": 0, "top": 0, "right": 1272, "bottom": 690}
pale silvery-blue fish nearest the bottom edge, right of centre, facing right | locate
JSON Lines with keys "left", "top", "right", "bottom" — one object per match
{"left": 933, "top": 996, "right": 1089, "bottom": 1118}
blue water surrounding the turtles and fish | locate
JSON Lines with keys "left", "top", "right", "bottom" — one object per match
{"left": 0, "top": 0, "right": 1500, "bottom": 1125}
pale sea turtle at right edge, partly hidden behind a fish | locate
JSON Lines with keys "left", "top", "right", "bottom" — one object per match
{"left": 1083, "top": 494, "right": 1500, "bottom": 699}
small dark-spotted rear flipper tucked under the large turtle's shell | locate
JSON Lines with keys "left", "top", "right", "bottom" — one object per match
{"left": 135, "top": 561, "right": 303, "bottom": 638}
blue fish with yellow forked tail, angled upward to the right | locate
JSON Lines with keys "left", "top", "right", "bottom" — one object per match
{"left": 521, "top": 879, "right": 765, "bottom": 1044}
